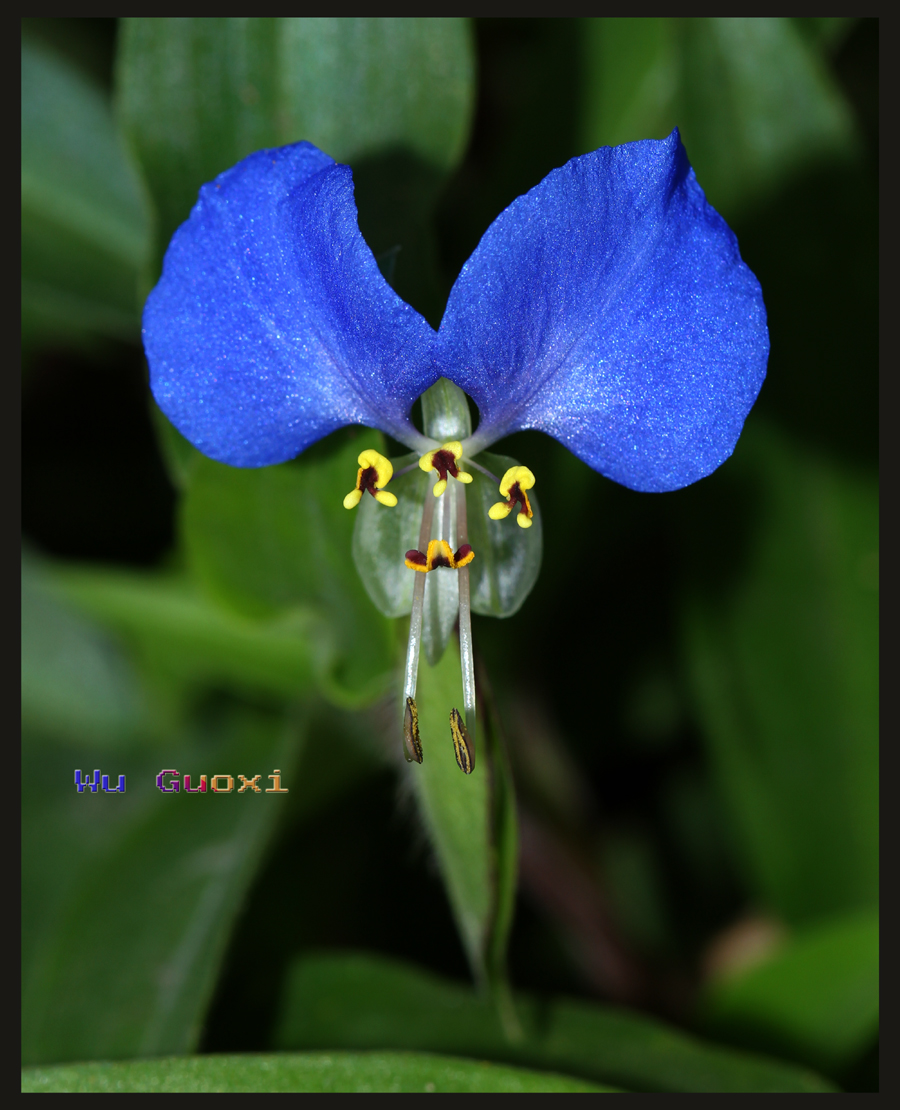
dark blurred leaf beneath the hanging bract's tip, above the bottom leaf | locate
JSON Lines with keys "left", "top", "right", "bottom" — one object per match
{"left": 275, "top": 945, "right": 831, "bottom": 1092}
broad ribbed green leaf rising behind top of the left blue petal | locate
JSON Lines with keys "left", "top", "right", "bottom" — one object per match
{"left": 118, "top": 18, "right": 474, "bottom": 265}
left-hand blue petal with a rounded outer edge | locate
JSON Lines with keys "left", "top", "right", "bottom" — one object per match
{"left": 143, "top": 143, "right": 437, "bottom": 466}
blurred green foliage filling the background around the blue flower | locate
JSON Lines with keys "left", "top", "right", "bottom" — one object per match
{"left": 22, "top": 19, "right": 878, "bottom": 1090}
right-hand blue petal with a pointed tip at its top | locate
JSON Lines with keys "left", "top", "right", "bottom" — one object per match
{"left": 438, "top": 130, "right": 769, "bottom": 492}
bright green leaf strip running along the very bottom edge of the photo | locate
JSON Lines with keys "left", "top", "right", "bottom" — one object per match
{"left": 22, "top": 1052, "right": 610, "bottom": 1094}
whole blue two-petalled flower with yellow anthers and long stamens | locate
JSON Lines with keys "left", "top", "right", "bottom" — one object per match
{"left": 143, "top": 130, "right": 769, "bottom": 773}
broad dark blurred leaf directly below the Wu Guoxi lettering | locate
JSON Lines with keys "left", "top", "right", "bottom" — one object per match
{"left": 22, "top": 713, "right": 302, "bottom": 1063}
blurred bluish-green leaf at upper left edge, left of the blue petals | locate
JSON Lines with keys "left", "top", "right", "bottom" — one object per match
{"left": 21, "top": 39, "right": 150, "bottom": 339}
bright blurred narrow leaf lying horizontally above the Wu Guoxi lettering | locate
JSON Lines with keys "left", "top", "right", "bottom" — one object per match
{"left": 54, "top": 566, "right": 334, "bottom": 698}
